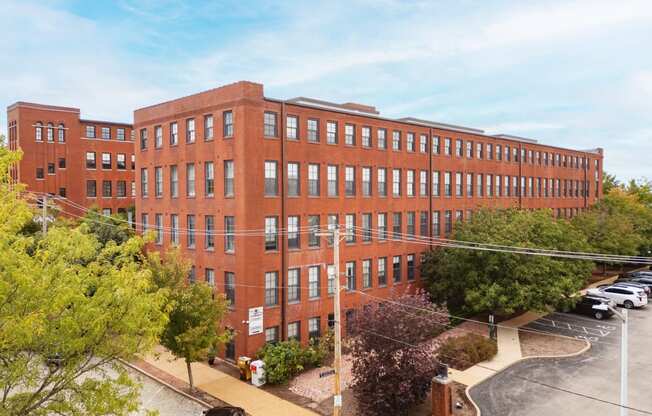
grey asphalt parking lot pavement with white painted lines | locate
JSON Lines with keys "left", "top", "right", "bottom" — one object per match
{"left": 470, "top": 306, "right": 652, "bottom": 416}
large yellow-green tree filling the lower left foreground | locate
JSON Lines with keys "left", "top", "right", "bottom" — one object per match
{"left": 0, "top": 145, "right": 167, "bottom": 416}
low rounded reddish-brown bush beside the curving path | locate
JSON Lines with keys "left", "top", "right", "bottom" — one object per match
{"left": 438, "top": 333, "right": 498, "bottom": 370}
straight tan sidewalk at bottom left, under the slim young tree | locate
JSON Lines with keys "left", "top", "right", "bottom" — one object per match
{"left": 143, "top": 347, "right": 316, "bottom": 416}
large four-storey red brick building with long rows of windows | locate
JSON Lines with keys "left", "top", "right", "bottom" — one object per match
{"left": 134, "top": 82, "right": 602, "bottom": 358}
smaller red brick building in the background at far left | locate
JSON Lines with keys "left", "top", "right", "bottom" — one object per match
{"left": 7, "top": 102, "right": 135, "bottom": 216}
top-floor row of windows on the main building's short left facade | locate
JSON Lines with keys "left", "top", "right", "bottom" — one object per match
{"left": 140, "top": 110, "right": 233, "bottom": 150}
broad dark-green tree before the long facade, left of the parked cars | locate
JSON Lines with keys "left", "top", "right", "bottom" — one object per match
{"left": 421, "top": 209, "right": 593, "bottom": 314}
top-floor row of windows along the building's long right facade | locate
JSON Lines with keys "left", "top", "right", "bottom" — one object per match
{"left": 263, "top": 111, "right": 597, "bottom": 169}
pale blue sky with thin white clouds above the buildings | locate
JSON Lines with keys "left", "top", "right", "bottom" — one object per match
{"left": 0, "top": 0, "right": 652, "bottom": 180}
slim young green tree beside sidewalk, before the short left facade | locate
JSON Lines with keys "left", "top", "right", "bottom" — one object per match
{"left": 149, "top": 251, "right": 231, "bottom": 391}
